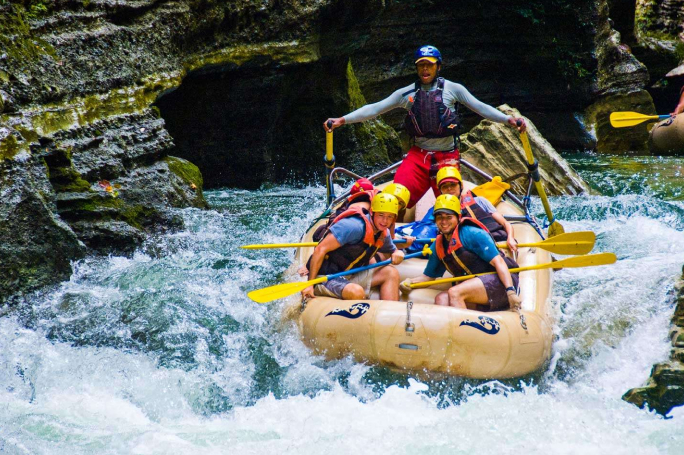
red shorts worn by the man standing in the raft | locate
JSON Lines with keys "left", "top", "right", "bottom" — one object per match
{"left": 394, "top": 146, "right": 461, "bottom": 208}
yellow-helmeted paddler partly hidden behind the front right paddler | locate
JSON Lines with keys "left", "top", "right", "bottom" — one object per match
{"left": 437, "top": 166, "right": 518, "bottom": 252}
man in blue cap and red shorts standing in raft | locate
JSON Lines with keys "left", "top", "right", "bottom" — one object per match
{"left": 323, "top": 46, "right": 525, "bottom": 208}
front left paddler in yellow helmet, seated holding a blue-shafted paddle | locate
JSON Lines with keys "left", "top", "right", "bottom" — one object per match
{"left": 302, "top": 193, "right": 404, "bottom": 301}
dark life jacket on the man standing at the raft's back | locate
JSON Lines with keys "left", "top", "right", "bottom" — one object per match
{"left": 402, "top": 77, "right": 460, "bottom": 138}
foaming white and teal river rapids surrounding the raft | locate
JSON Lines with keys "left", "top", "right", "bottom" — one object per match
{"left": 0, "top": 155, "right": 684, "bottom": 455}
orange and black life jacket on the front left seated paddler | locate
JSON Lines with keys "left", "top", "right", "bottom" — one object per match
{"left": 307, "top": 206, "right": 389, "bottom": 276}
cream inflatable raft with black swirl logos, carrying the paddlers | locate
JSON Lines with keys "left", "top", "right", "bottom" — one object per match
{"left": 289, "top": 182, "right": 553, "bottom": 379}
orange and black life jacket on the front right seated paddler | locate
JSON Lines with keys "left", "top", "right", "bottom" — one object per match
{"left": 435, "top": 218, "right": 518, "bottom": 277}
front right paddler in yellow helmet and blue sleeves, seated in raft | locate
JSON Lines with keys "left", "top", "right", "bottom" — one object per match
{"left": 400, "top": 194, "right": 521, "bottom": 311}
